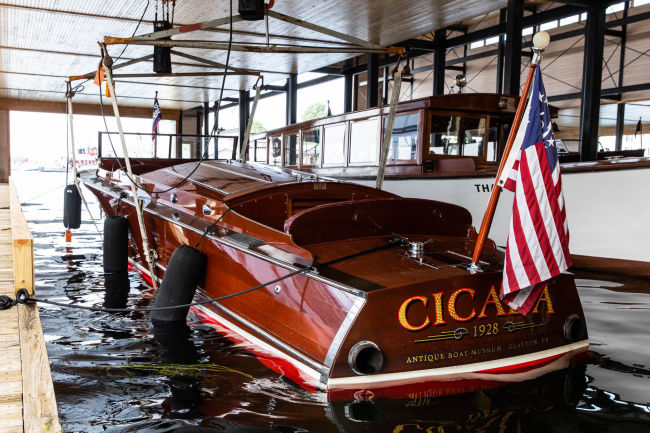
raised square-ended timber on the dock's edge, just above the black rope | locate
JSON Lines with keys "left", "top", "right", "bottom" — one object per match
{"left": 9, "top": 180, "right": 34, "bottom": 294}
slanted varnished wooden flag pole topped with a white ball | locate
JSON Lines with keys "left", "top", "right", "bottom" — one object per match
{"left": 470, "top": 32, "right": 549, "bottom": 271}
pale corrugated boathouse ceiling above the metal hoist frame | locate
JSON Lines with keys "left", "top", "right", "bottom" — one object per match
{"left": 0, "top": 0, "right": 506, "bottom": 109}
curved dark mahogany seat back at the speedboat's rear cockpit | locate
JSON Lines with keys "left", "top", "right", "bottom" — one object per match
{"left": 284, "top": 198, "right": 472, "bottom": 246}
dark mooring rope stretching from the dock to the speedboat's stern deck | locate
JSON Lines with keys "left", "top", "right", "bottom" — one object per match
{"left": 6, "top": 236, "right": 402, "bottom": 313}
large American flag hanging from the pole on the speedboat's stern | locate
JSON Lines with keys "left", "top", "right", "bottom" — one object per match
{"left": 501, "top": 67, "right": 571, "bottom": 315}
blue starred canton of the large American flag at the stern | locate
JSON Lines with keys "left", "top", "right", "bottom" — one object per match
{"left": 521, "top": 66, "right": 558, "bottom": 172}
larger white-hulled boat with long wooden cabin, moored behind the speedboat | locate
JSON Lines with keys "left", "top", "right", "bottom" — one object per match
{"left": 247, "top": 93, "right": 650, "bottom": 261}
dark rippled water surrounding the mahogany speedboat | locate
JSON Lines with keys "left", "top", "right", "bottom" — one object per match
{"left": 15, "top": 172, "right": 650, "bottom": 433}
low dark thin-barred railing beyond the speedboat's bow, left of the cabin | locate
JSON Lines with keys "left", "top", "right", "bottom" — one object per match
{"left": 97, "top": 131, "right": 238, "bottom": 159}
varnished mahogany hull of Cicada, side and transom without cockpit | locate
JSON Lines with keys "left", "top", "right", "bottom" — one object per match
{"left": 84, "top": 164, "right": 588, "bottom": 398}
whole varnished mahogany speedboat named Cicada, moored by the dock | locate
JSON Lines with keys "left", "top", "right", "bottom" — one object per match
{"left": 82, "top": 158, "right": 588, "bottom": 397}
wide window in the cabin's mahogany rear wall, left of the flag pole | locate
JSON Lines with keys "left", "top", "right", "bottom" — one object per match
{"left": 429, "top": 114, "right": 486, "bottom": 157}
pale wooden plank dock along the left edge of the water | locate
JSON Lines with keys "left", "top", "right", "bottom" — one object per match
{"left": 0, "top": 183, "right": 61, "bottom": 433}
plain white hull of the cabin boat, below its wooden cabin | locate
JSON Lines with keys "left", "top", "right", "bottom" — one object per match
{"left": 358, "top": 167, "right": 650, "bottom": 261}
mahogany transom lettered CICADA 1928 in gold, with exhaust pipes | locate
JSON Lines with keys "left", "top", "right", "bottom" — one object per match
{"left": 327, "top": 273, "right": 589, "bottom": 399}
